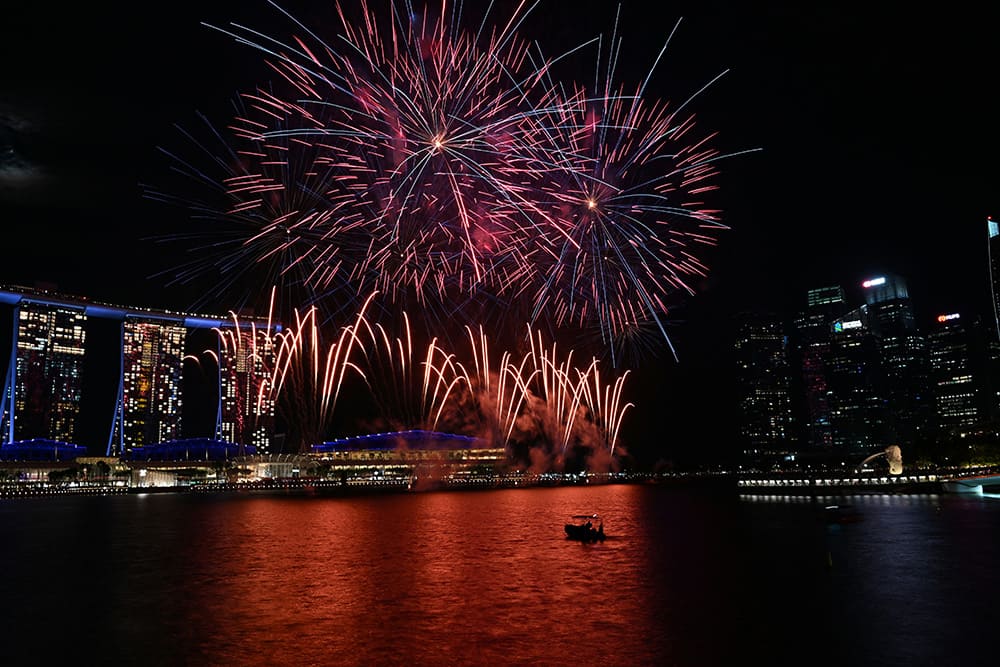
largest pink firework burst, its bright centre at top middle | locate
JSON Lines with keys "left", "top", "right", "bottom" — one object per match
{"left": 205, "top": 2, "right": 561, "bottom": 304}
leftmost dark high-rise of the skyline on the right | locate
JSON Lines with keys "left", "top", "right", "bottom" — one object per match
{"left": 735, "top": 313, "right": 796, "bottom": 462}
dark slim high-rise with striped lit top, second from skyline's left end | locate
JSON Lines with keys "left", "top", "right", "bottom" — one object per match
{"left": 794, "top": 285, "right": 847, "bottom": 450}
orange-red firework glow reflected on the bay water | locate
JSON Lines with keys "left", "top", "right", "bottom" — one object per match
{"left": 166, "top": 486, "right": 680, "bottom": 665}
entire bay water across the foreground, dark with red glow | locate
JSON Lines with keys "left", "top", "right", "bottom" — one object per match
{"left": 0, "top": 485, "right": 1000, "bottom": 666}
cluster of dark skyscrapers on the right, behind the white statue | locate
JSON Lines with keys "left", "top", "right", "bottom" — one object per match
{"left": 735, "top": 274, "right": 1000, "bottom": 467}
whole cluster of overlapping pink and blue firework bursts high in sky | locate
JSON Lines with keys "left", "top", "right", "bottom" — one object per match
{"left": 152, "top": 0, "right": 740, "bottom": 365}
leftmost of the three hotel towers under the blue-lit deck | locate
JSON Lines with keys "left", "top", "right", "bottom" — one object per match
{"left": 3, "top": 300, "right": 87, "bottom": 444}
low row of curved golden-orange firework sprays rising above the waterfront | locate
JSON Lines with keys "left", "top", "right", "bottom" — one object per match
{"left": 216, "top": 294, "right": 631, "bottom": 466}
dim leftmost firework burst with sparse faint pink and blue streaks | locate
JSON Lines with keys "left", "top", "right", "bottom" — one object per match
{"left": 143, "top": 105, "right": 369, "bottom": 317}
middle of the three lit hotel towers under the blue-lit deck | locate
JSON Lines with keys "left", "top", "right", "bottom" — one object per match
{"left": 112, "top": 317, "right": 187, "bottom": 455}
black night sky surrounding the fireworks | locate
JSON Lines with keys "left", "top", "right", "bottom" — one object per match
{"left": 0, "top": 0, "right": 1000, "bottom": 468}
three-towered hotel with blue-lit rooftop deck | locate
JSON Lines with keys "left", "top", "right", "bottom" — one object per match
{"left": 0, "top": 287, "right": 278, "bottom": 457}
